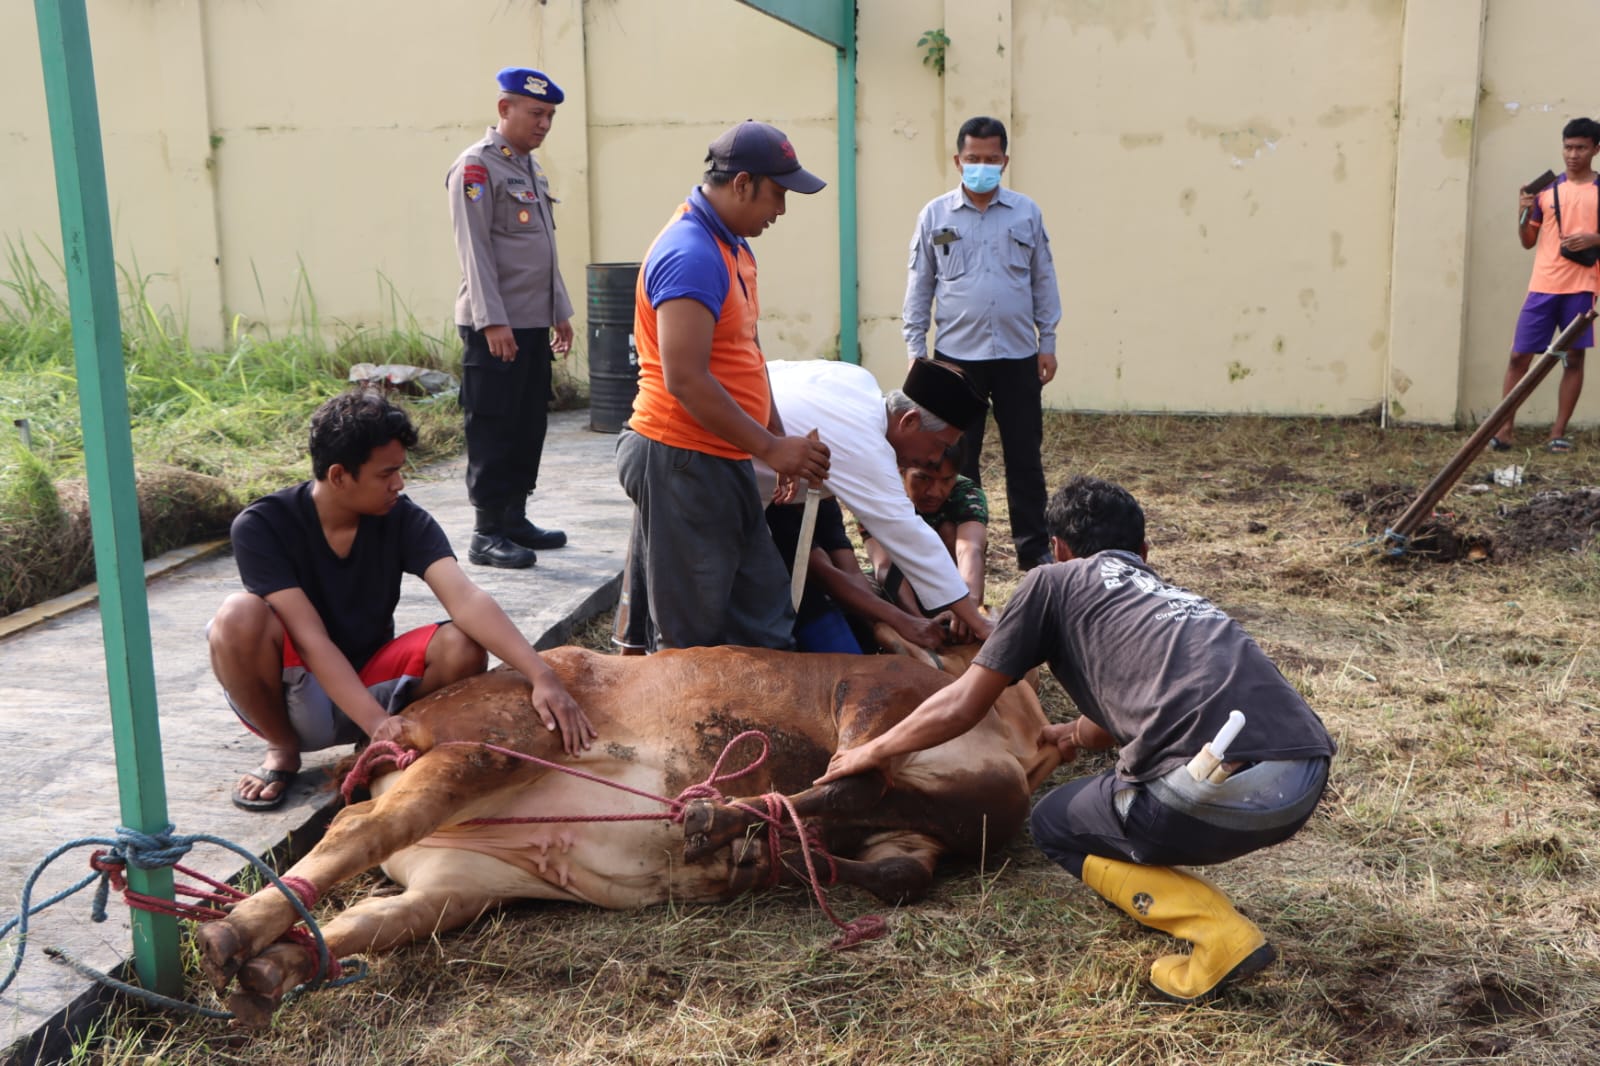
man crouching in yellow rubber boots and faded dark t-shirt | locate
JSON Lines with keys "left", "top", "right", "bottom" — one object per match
{"left": 818, "top": 477, "right": 1334, "bottom": 1002}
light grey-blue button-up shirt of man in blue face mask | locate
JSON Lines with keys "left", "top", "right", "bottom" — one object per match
{"left": 901, "top": 186, "right": 1061, "bottom": 359}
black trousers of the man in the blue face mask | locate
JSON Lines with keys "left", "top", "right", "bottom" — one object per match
{"left": 934, "top": 352, "right": 1050, "bottom": 570}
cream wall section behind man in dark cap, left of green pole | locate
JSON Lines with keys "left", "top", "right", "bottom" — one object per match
{"left": 585, "top": 0, "right": 838, "bottom": 359}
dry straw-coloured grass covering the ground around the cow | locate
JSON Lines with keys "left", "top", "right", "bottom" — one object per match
{"left": 46, "top": 416, "right": 1600, "bottom": 1066}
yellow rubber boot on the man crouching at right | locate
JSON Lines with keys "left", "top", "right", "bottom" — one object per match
{"left": 1083, "top": 855, "right": 1277, "bottom": 1004}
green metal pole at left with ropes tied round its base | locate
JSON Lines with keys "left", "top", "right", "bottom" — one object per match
{"left": 34, "top": 0, "right": 182, "bottom": 996}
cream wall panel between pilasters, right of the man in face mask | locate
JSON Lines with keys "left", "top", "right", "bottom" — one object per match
{"left": 1011, "top": 0, "right": 1400, "bottom": 415}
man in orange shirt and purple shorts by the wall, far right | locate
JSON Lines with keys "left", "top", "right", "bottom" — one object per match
{"left": 1490, "top": 118, "right": 1600, "bottom": 453}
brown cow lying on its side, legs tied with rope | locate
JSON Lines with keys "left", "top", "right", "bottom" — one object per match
{"left": 197, "top": 633, "right": 1059, "bottom": 1024}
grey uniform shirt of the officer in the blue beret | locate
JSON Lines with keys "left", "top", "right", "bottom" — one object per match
{"left": 445, "top": 126, "right": 573, "bottom": 330}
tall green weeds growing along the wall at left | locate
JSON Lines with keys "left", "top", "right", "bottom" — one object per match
{"left": 0, "top": 238, "right": 461, "bottom": 613}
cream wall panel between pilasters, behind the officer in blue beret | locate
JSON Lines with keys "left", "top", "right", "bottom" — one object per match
{"left": 205, "top": 0, "right": 589, "bottom": 344}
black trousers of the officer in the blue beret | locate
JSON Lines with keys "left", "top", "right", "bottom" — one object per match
{"left": 456, "top": 325, "right": 555, "bottom": 511}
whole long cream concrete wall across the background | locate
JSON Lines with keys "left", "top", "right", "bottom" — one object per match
{"left": 9, "top": 0, "right": 1600, "bottom": 423}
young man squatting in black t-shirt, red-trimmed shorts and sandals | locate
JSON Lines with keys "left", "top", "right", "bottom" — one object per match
{"left": 206, "top": 391, "right": 595, "bottom": 810}
